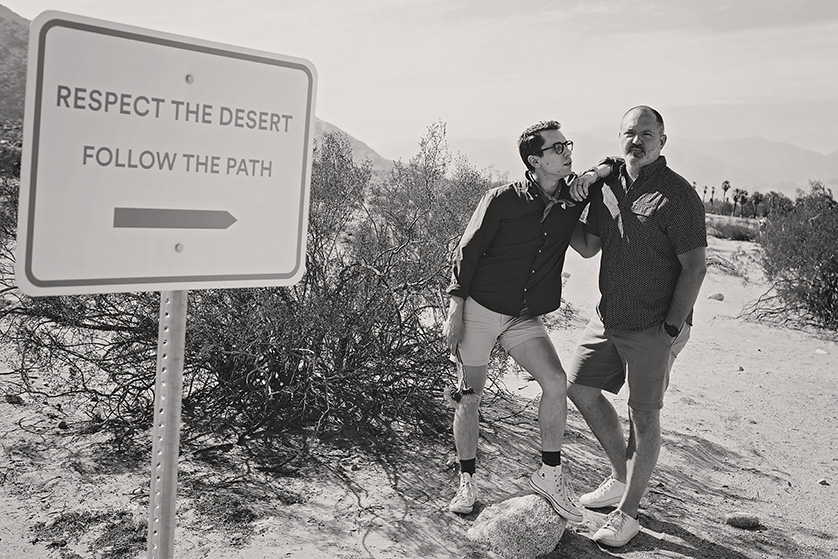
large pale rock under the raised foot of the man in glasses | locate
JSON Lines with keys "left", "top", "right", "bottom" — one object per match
{"left": 468, "top": 495, "right": 567, "bottom": 559}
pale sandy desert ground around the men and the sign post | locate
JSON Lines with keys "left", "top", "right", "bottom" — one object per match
{"left": 0, "top": 238, "right": 838, "bottom": 559}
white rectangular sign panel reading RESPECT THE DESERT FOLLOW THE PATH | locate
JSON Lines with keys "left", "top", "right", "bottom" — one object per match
{"left": 16, "top": 12, "right": 317, "bottom": 295}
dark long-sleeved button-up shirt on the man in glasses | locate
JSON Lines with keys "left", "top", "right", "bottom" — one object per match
{"left": 448, "top": 173, "right": 585, "bottom": 316}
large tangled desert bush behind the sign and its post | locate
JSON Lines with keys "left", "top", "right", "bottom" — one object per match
{"left": 0, "top": 124, "right": 498, "bottom": 450}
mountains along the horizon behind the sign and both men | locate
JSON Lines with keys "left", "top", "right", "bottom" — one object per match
{"left": 0, "top": 5, "right": 838, "bottom": 199}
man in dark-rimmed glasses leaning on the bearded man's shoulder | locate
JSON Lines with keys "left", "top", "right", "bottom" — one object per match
{"left": 443, "top": 120, "right": 596, "bottom": 522}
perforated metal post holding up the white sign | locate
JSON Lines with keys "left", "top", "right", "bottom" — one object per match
{"left": 148, "top": 291, "right": 189, "bottom": 559}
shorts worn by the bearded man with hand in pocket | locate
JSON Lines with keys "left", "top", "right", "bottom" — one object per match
{"left": 567, "top": 315, "right": 691, "bottom": 410}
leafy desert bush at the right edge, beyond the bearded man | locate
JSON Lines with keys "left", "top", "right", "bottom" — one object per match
{"left": 750, "top": 181, "right": 838, "bottom": 330}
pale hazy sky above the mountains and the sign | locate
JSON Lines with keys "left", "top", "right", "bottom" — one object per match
{"left": 6, "top": 0, "right": 838, "bottom": 158}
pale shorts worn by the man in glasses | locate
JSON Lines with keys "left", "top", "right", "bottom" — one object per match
{"left": 458, "top": 297, "right": 550, "bottom": 367}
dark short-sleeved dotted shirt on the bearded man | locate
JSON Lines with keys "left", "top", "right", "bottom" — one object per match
{"left": 585, "top": 156, "right": 707, "bottom": 330}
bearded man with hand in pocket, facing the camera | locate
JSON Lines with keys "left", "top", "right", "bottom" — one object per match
{"left": 568, "top": 105, "right": 707, "bottom": 546}
